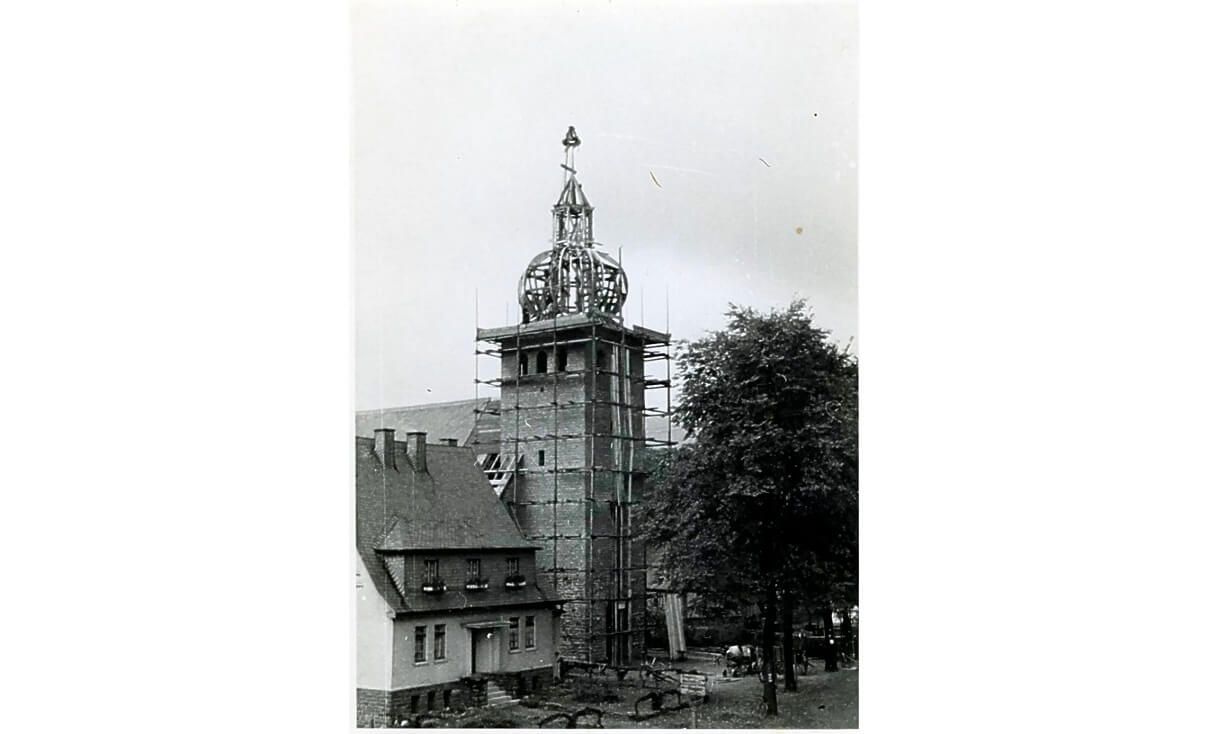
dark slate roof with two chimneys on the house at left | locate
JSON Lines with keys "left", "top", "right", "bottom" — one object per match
{"left": 356, "top": 437, "right": 546, "bottom": 612}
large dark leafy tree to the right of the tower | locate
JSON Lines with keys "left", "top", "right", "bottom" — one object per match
{"left": 644, "top": 301, "right": 857, "bottom": 716}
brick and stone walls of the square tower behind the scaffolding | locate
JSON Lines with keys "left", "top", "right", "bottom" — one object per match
{"left": 501, "top": 329, "right": 646, "bottom": 663}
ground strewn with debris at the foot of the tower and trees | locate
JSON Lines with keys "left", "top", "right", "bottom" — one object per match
{"left": 430, "top": 658, "right": 858, "bottom": 729}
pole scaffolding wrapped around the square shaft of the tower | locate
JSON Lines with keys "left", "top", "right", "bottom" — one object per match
{"left": 474, "top": 316, "right": 673, "bottom": 664}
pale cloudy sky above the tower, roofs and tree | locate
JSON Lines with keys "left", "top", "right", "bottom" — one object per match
{"left": 352, "top": 1, "right": 858, "bottom": 410}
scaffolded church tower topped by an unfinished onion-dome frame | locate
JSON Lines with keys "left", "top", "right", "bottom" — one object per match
{"left": 477, "top": 128, "right": 670, "bottom": 665}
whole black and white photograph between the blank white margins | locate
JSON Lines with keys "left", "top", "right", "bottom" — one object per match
{"left": 352, "top": 1, "right": 859, "bottom": 729}
